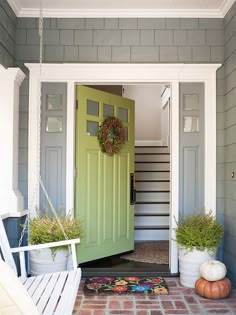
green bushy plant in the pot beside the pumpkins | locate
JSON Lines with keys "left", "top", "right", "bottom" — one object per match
{"left": 176, "top": 209, "right": 224, "bottom": 251}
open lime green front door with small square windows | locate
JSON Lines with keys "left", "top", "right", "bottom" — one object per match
{"left": 75, "top": 86, "right": 134, "bottom": 263}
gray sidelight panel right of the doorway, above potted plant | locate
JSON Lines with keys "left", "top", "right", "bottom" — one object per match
{"left": 179, "top": 83, "right": 205, "bottom": 215}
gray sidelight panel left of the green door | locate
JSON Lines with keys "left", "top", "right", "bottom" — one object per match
{"left": 40, "top": 82, "right": 67, "bottom": 214}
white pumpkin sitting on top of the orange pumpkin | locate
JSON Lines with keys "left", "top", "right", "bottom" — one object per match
{"left": 200, "top": 260, "right": 227, "bottom": 281}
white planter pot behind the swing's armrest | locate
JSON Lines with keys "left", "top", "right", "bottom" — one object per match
{"left": 29, "top": 248, "right": 68, "bottom": 276}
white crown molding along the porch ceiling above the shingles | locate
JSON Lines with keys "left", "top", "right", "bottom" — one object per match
{"left": 7, "top": 0, "right": 235, "bottom": 18}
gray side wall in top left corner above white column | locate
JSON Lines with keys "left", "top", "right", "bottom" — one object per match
{"left": 0, "top": 0, "right": 16, "bottom": 68}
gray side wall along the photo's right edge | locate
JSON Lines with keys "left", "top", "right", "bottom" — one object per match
{"left": 224, "top": 3, "right": 236, "bottom": 286}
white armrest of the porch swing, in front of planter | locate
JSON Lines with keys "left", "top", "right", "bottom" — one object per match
{"left": 11, "top": 238, "right": 80, "bottom": 277}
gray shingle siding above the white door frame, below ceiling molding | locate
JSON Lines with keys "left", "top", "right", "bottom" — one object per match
{"left": 16, "top": 18, "right": 224, "bottom": 63}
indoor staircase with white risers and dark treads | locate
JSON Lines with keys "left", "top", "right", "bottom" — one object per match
{"left": 134, "top": 146, "right": 170, "bottom": 241}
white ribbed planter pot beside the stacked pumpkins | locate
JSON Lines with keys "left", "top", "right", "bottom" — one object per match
{"left": 179, "top": 248, "right": 216, "bottom": 288}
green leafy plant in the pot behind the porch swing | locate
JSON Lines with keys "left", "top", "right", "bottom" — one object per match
{"left": 28, "top": 208, "right": 83, "bottom": 254}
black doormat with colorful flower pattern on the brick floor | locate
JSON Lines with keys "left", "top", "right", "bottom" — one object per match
{"left": 84, "top": 276, "right": 169, "bottom": 295}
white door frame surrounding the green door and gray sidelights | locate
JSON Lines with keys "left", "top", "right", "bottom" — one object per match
{"left": 25, "top": 63, "right": 221, "bottom": 273}
